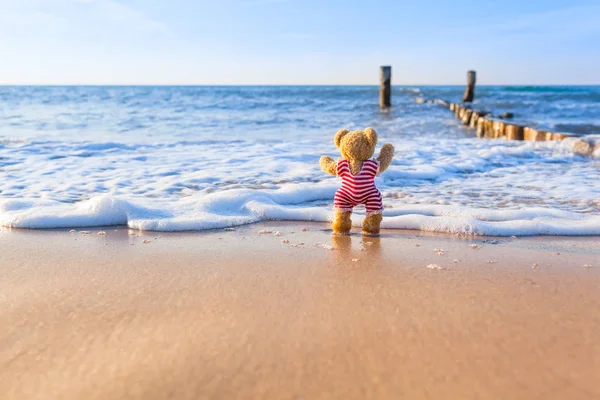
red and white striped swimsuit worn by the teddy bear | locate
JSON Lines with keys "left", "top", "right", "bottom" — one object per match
{"left": 333, "top": 160, "right": 383, "bottom": 216}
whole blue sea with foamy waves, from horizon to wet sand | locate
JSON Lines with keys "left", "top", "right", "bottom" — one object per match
{"left": 0, "top": 86, "right": 600, "bottom": 236}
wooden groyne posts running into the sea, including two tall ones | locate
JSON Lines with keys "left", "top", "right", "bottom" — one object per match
{"left": 379, "top": 66, "right": 600, "bottom": 155}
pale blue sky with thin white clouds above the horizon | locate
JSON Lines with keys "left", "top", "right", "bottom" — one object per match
{"left": 0, "top": 0, "right": 600, "bottom": 85}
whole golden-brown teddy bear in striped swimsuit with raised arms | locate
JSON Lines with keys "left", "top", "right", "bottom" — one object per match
{"left": 319, "top": 128, "right": 394, "bottom": 235}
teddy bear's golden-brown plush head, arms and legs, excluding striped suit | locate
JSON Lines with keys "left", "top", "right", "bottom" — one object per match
{"left": 319, "top": 128, "right": 394, "bottom": 235}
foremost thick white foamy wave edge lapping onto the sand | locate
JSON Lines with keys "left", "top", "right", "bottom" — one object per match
{"left": 0, "top": 184, "right": 600, "bottom": 236}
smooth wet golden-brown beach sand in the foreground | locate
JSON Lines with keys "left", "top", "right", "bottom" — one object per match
{"left": 0, "top": 223, "right": 600, "bottom": 400}
